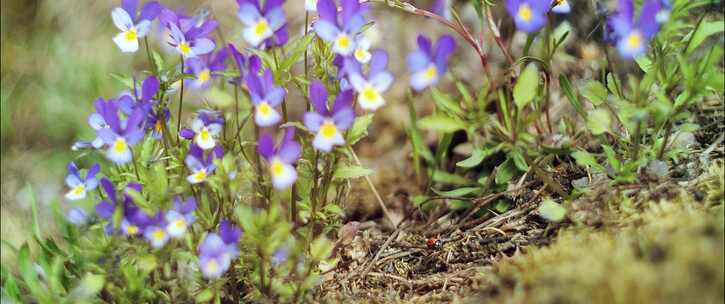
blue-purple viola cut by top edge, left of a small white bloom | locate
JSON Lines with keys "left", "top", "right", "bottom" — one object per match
{"left": 506, "top": 0, "right": 551, "bottom": 33}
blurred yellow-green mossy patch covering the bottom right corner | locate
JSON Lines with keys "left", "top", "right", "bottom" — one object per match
{"left": 474, "top": 162, "right": 725, "bottom": 303}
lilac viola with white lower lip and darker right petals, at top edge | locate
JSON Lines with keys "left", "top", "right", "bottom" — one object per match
{"left": 237, "top": 0, "right": 288, "bottom": 47}
